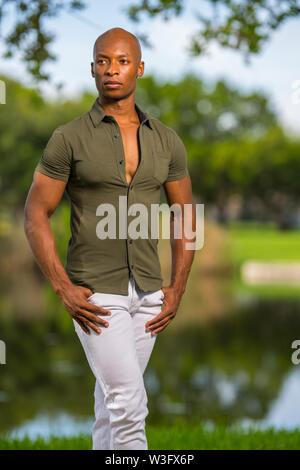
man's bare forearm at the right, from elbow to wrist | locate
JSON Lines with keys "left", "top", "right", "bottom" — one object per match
{"left": 170, "top": 205, "right": 196, "bottom": 294}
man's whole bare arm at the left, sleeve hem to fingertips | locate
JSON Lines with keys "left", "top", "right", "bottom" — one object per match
{"left": 24, "top": 171, "right": 110, "bottom": 334}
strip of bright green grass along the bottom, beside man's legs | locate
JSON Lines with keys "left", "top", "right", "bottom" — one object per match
{"left": 0, "top": 424, "right": 300, "bottom": 450}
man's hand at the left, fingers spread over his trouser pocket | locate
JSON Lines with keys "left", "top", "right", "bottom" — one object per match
{"left": 58, "top": 284, "right": 111, "bottom": 335}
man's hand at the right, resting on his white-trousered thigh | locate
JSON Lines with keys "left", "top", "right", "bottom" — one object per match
{"left": 145, "top": 286, "right": 182, "bottom": 336}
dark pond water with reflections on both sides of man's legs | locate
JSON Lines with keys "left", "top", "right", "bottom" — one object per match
{"left": 0, "top": 299, "right": 300, "bottom": 436}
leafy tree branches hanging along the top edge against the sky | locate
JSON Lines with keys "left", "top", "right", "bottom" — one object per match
{"left": 0, "top": 0, "right": 300, "bottom": 81}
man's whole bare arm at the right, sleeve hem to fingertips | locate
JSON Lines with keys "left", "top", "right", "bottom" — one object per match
{"left": 145, "top": 174, "right": 196, "bottom": 335}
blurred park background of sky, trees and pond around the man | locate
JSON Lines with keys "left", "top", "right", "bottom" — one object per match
{"left": 0, "top": 0, "right": 300, "bottom": 437}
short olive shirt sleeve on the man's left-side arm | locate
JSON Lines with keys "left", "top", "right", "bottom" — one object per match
{"left": 35, "top": 129, "right": 71, "bottom": 181}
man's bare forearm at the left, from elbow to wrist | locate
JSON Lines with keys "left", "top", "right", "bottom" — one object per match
{"left": 24, "top": 214, "right": 72, "bottom": 294}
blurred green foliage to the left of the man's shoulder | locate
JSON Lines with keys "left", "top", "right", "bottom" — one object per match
{"left": 0, "top": 76, "right": 95, "bottom": 207}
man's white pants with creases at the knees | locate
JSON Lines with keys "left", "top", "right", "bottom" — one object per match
{"left": 73, "top": 274, "right": 164, "bottom": 450}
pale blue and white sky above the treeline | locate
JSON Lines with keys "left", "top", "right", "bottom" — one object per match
{"left": 0, "top": 0, "right": 300, "bottom": 136}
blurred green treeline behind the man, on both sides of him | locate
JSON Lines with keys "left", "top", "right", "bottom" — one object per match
{"left": 0, "top": 75, "right": 300, "bottom": 228}
